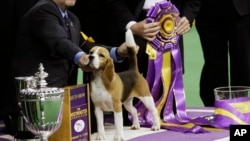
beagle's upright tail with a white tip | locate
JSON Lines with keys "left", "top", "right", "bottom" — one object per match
{"left": 126, "top": 29, "right": 138, "bottom": 71}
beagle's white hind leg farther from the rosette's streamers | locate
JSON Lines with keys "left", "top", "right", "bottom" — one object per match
{"left": 123, "top": 98, "right": 140, "bottom": 129}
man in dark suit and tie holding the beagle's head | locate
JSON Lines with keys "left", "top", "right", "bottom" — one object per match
{"left": 11, "top": 0, "right": 134, "bottom": 135}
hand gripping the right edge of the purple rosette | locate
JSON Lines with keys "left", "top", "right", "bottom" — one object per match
{"left": 176, "top": 17, "right": 191, "bottom": 35}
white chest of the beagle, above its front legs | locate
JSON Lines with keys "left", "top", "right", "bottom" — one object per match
{"left": 91, "top": 77, "right": 113, "bottom": 111}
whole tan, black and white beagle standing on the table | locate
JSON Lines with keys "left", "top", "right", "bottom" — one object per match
{"left": 82, "top": 31, "right": 160, "bottom": 141}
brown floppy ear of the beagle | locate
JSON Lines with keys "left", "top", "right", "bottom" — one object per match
{"left": 102, "top": 58, "right": 115, "bottom": 84}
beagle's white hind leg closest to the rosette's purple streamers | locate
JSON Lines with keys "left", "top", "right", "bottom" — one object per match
{"left": 139, "top": 96, "right": 160, "bottom": 130}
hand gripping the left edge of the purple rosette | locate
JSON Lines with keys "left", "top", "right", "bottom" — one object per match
{"left": 130, "top": 20, "right": 160, "bottom": 41}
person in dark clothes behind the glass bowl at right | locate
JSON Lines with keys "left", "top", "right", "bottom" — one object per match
{"left": 196, "top": 0, "right": 250, "bottom": 106}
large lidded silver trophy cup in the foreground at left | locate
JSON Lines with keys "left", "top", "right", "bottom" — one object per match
{"left": 20, "top": 64, "right": 64, "bottom": 141}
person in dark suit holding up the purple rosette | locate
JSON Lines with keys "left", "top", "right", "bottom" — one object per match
{"left": 72, "top": 0, "right": 200, "bottom": 124}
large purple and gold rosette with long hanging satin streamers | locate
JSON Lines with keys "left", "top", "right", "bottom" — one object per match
{"left": 130, "top": 0, "right": 213, "bottom": 133}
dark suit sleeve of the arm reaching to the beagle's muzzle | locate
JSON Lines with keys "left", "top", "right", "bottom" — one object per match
{"left": 23, "top": 4, "right": 81, "bottom": 60}
